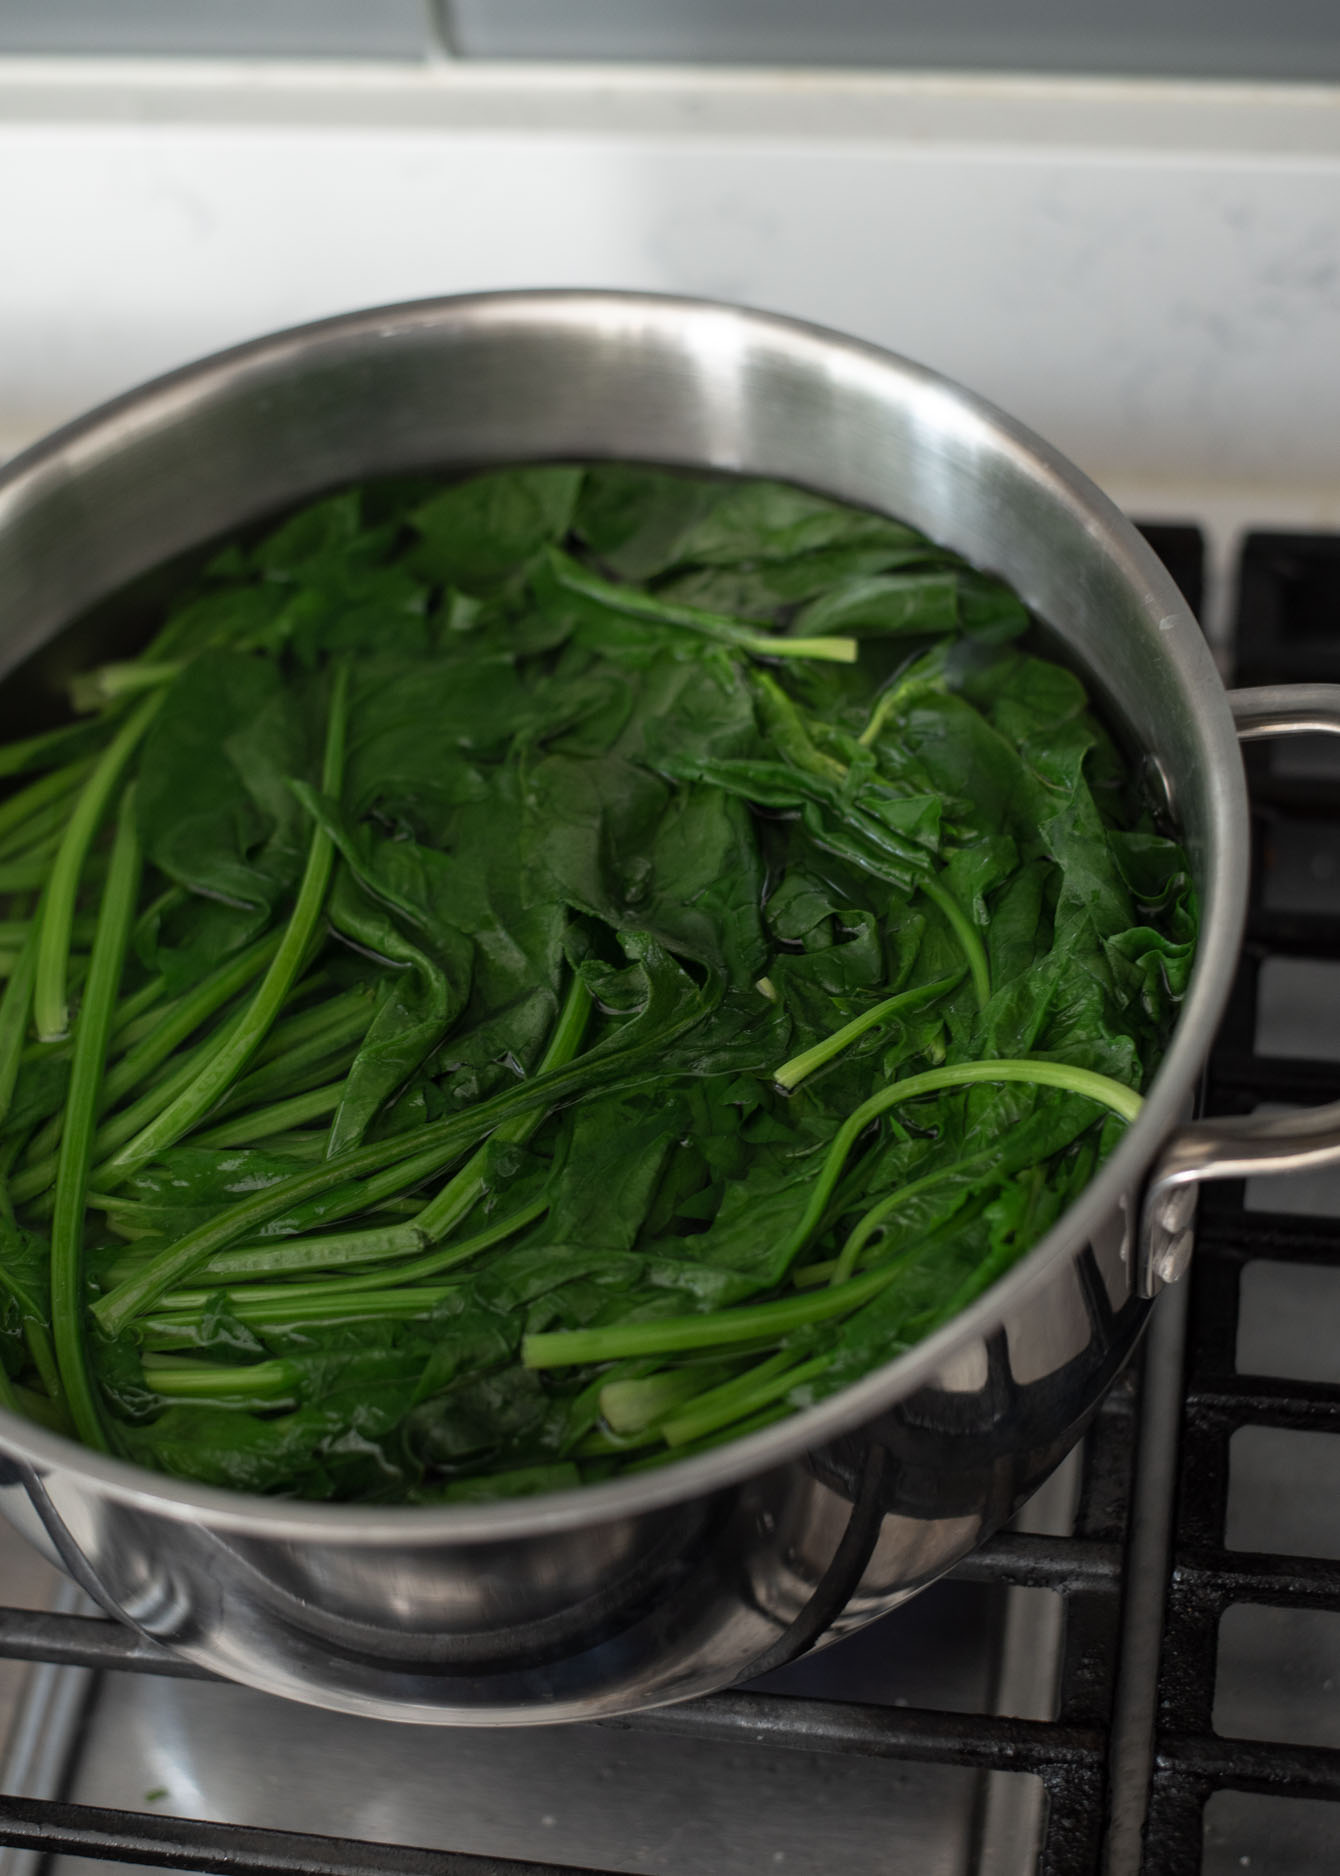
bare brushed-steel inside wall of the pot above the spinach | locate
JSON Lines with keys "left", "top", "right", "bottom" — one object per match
{"left": 0, "top": 295, "right": 1246, "bottom": 1523}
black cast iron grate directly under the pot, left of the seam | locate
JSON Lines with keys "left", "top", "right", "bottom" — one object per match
{"left": 0, "top": 1403, "right": 1135, "bottom": 1876}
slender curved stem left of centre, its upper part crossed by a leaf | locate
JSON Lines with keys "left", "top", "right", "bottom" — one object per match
{"left": 103, "top": 664, "right": 349, "bottom": 1171}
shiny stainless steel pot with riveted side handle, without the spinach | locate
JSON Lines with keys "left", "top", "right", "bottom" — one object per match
{"left": 0, "top": 293, "right": 1340, "bottom": 1724}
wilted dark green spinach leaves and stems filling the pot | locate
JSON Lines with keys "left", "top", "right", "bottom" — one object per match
{"left": 0, "top": 467, "right": 1195, "bottom": 1503}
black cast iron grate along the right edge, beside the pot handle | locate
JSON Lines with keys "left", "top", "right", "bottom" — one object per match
{"left": 1145, "top": 535, "right": 1340, "bottom": 1876}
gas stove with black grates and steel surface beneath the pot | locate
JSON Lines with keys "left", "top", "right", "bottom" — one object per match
{"left": 0, "top": 523, "right": 1340, "bottom": 1876}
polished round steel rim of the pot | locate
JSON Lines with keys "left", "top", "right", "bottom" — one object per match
{"left": 0, "top": 289, "right": 1248, "bottom": 1546}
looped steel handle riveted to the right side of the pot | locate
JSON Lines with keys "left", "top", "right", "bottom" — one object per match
{"left": 1135, "top": 685, "right": 1340, "bottom": 1296}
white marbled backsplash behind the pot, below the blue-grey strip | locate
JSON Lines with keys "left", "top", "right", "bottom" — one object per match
{"left": 0, "top": 58, "right": 1340, "bottom": 615}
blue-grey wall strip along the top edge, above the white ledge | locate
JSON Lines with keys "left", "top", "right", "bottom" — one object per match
{"left": 0, "top": 0, "right": 1340, "bottom": 81}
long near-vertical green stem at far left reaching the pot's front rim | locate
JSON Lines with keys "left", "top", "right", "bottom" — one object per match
{"left": 51, "top": 784, "right": 139, "bottom": 1452}
